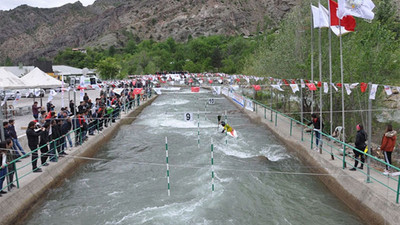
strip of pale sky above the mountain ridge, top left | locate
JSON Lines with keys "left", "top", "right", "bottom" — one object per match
{"left": 0, "top": 0, "right": 95, "bottom": 10}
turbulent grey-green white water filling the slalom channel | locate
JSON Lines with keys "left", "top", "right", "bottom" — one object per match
{"left": 27, "top": 90, "right": 361, "bottom": 225}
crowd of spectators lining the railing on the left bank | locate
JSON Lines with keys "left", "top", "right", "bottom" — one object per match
{"left": 0, "top": 88, "right": 151, "bottom": 197}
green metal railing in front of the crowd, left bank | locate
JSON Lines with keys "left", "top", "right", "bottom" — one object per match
{"left": 0, "top": 92, "right": 152, "bottom": 191}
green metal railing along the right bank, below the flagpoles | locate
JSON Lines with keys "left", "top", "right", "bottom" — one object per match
{"left": 252, "top": 99, "right": 400, "bottom": 203}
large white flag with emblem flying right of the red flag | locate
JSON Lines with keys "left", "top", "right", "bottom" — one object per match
{"left": 337, "top": 0, "right": 375, "bottom": 20}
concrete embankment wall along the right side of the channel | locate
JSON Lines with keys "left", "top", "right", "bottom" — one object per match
{"left": 227, "top": 97, "right": 400, "bottom": 225}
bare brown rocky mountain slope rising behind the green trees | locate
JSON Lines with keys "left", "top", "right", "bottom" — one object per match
{"left": 0, "top": 0, "right": 301, "bottom": 64}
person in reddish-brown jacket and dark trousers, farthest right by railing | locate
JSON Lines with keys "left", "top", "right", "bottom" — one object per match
{"left": 381, "top": 124, "right": 397, "bottom": 175}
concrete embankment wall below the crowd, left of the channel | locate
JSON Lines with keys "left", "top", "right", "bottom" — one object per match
{"left": 0, "top": 96, "right": 157, "bottom": 225}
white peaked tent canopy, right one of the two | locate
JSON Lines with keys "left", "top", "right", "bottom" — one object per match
{"left": 21, "top": 67, "right": 62, "bottom": 88}
